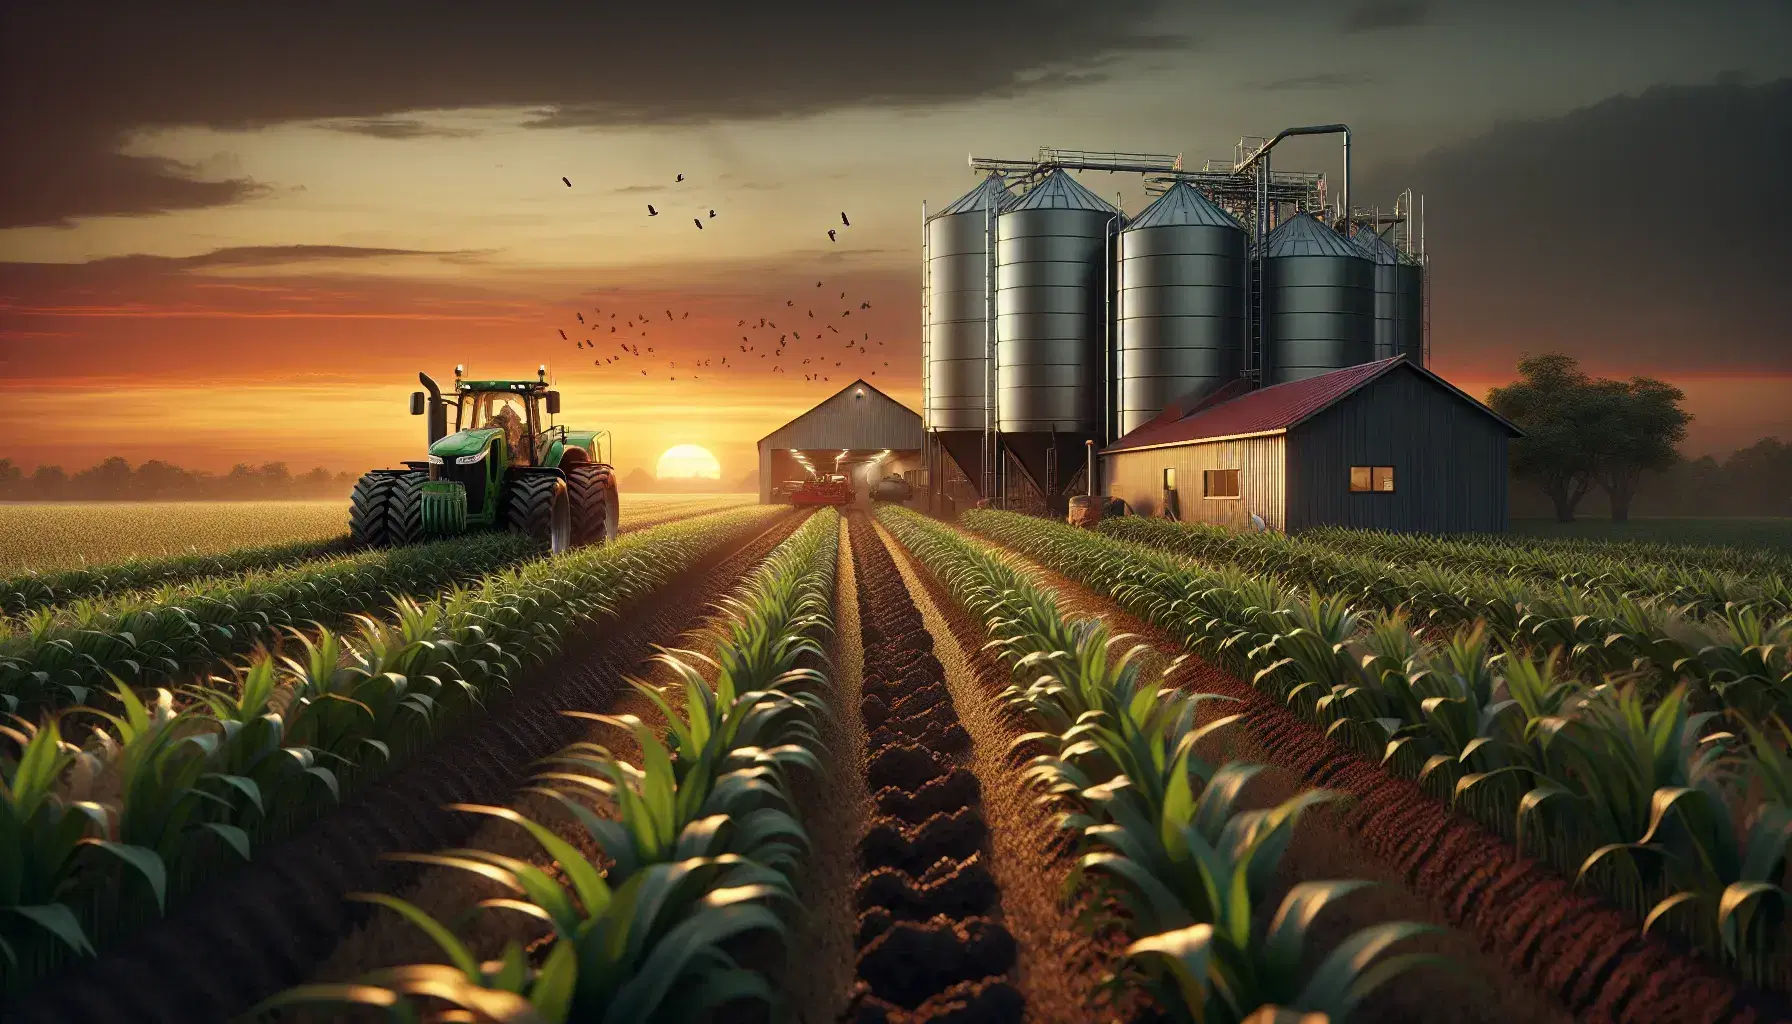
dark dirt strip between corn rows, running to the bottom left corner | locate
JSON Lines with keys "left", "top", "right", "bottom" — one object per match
{"left": 0, "top": 513, "right": 805, "bottom": 1024}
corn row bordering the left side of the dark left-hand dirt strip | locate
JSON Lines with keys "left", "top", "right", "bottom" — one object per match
{"left": 0, "top": 508, "right": 776, "bottom": 981}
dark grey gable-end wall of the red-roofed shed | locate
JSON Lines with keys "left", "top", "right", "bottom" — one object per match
{"left": 1287, "top": 368, "right": 1509, "bottom": 533}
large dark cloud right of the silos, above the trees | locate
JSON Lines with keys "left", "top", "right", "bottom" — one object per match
{"left": 1358, "top": 79, "right": 1792, "bottom": 371}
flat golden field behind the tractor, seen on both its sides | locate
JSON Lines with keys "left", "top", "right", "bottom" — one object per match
{"left": 0, "top": 493, "right": 756, "bottom": 574}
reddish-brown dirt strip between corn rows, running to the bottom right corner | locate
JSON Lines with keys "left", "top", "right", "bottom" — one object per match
{"left": 966, "top": 533, "right": 1792, "bottom": 1024}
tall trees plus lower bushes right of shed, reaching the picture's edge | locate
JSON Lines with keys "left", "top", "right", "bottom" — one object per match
{"left": 1487, "top": 353, "right": 1792, "bottom": 522}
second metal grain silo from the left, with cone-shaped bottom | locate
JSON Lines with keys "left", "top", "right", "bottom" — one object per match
{"left": 996, "top": 170, "right": 1122, "bottom": 509}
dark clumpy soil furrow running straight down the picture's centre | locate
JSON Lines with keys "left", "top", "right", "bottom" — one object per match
{"left": 846, "top": 513, "right": 1023, "bottom": 1024}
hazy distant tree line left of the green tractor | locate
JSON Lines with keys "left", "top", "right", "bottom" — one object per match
{"left": 0, "top": 456, "right": 355, "bottom": 502}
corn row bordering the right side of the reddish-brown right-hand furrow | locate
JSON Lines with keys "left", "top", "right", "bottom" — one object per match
{"left": 961, "top": 511, "right": 1792, "bottom": 990}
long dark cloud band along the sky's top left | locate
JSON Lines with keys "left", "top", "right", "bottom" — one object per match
{"left": 0, "top": 0, "right": 1183, "bottom": 228}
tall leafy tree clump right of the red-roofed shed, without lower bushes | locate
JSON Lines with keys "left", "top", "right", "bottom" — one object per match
{"left": 1487, "top": 353, "right": 1692, "bottom": 522}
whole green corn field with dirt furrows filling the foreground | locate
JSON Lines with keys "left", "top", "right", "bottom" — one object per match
{"left": 0, "top": 499, "right": 1792, "bottom": 1024}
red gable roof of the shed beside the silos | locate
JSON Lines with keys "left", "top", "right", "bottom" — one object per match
{"left": 1102, "top": 355, "right": 1523, "bottom": 454}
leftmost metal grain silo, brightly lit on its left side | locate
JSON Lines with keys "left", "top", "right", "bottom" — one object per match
{"left": 921, "top": 176, "right": 1014, "bottom": 494}
